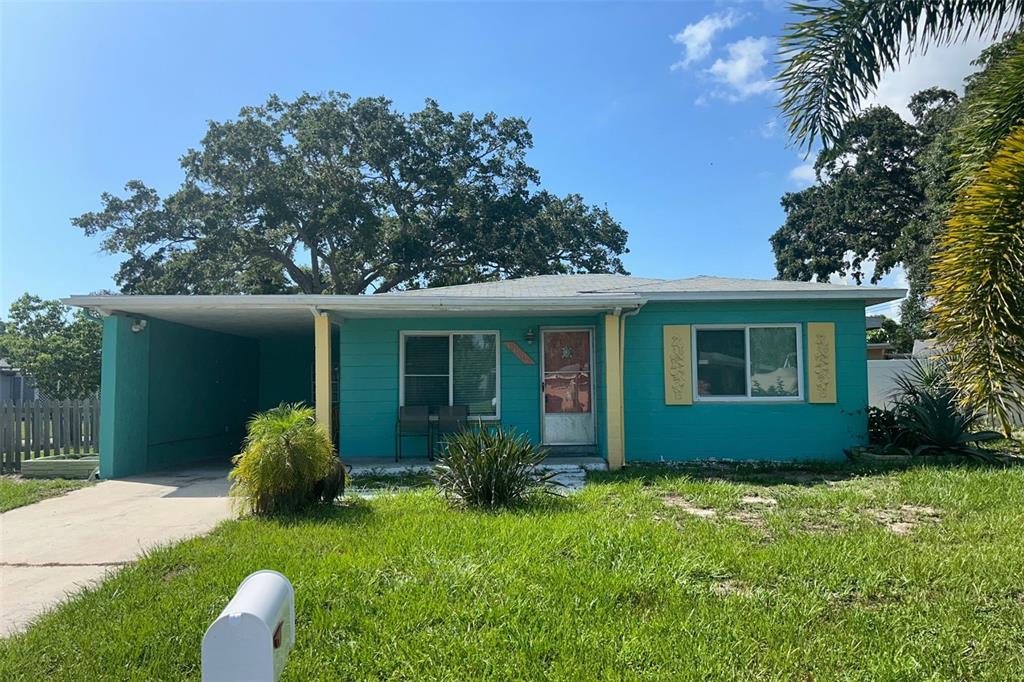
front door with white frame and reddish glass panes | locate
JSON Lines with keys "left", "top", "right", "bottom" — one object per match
{"left": 541, "top": 329, "right": 594, "bottom": 445}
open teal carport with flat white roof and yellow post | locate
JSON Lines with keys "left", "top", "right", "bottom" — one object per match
{"left": 67, "top": 296, "right": 338, "bottom": 478}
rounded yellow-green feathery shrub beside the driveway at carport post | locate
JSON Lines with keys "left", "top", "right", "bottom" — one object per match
{"left": 228, "top": 403, "right": 345, "bottom": 514}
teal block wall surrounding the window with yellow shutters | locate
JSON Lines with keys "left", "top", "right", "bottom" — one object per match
{"left": 624, "top": 301, "right": 867, "bottom": 463}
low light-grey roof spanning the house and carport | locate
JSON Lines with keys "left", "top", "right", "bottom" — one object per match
{"left": 63, "top": 274, "right": 905, "bottom": 335}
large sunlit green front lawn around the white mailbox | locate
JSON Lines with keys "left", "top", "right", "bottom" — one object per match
{"left": 0, "top": 458, "right": 1024, "bottom": 680}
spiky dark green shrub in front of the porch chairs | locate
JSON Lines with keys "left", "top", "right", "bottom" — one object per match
{"left": 434, "top": 427, "right": 555, "bottom": 507}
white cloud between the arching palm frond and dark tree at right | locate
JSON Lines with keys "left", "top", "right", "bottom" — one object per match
{"left": 863, "top": 36, "right": 993, "bottom": 121}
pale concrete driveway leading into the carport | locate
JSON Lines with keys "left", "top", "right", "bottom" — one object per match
{"left": 0, "top": 465, "right": 231, "bottom": 637}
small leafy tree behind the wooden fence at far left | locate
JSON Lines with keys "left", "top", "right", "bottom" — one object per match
{"left": 0, "top": 294, "right": 102, "bottom": 399}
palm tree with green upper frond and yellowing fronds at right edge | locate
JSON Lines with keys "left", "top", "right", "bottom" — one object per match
{"left": 778, "top": 0, "right": 1024, "bottom": 434}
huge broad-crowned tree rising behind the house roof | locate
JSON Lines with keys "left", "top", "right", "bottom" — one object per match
{"left": 73, "top": 92, "right": 627, "bottom": 294}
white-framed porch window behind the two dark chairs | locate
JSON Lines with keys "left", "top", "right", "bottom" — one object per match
{"left": 401, "top": 332, "right": 499, "bottom": 417}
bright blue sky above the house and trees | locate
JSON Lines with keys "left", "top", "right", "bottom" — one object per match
{"left": 0, "top": 1, "right": 980, "bottom": 311}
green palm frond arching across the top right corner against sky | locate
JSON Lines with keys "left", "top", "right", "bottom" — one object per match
{"left": 777, "top": 0, "right": 1024, "bottom": 151}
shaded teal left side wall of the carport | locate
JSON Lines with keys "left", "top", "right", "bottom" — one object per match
{"left": 99, "top": 315, "right": 259, "bottom": 478}
